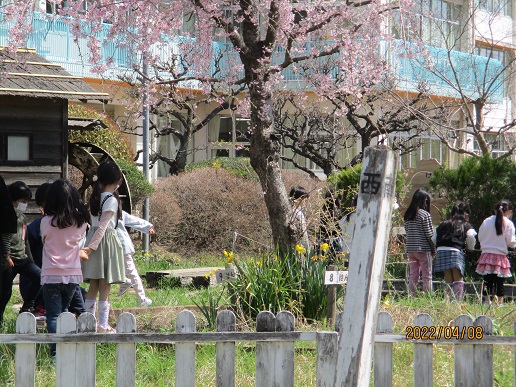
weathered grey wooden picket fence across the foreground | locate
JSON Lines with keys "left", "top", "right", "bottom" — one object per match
{"left": 0, "top": 310, "right": 516, "bottom": 387}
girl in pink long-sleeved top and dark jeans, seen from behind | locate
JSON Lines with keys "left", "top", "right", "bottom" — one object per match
{"left": 40, "top": 180, "right": 90, "bottom": 356}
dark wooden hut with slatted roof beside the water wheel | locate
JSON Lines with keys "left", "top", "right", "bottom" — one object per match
{"left": 0, "top": 49, "right": 109, "bottom": 213}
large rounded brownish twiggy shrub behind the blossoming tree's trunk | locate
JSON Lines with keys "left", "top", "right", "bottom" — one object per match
{"left": 151, "top": 168, "right": 317, "bottom": 253}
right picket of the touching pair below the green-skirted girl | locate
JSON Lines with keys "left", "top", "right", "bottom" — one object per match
{"left": 76, "top": 312, "right": 97, "bottom": 387}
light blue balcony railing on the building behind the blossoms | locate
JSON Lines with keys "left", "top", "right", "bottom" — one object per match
{"left": 0, "top": 12, "right": 504, "bottom": 102}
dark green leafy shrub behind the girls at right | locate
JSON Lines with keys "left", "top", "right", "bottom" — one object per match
{"left": 430, "top": 157, "right": 516, "bottom": 230}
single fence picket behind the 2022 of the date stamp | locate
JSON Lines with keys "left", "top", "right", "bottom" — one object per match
{"left": 414, "top": 313, "right": 434, "bottom": 387}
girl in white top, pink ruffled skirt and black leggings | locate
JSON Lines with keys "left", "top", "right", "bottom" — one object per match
{"left": 476, "top": 199, "right": 516, "bottom": 304}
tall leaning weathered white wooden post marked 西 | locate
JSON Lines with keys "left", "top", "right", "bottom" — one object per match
{"left": 334, "top": 146, "right": 398, "bottom": 387}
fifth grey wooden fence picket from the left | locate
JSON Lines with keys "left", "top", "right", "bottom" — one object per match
{"left": 176, "top": 310, "right": 195, "bottom": 387}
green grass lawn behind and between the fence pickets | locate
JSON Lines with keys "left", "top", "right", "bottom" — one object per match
{"left": 0, "top": 250, "right": 516, "bottom": 387}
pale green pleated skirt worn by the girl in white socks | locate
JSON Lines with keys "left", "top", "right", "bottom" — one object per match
{"left": 81, "top": 228, "right": 125, "bottom": 284}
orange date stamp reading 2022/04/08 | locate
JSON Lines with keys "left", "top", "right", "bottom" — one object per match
{"left": 405, "top": 325, "right": 484, "bottom": 340}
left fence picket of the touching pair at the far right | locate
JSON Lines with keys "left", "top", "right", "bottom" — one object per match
{"left": 454, "top": 314, "right": 476, "bottom": 386}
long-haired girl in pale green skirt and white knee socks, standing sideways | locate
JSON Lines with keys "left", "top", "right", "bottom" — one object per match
{"left": 82, "top": 161, "right": 125, "bottom": 333}
